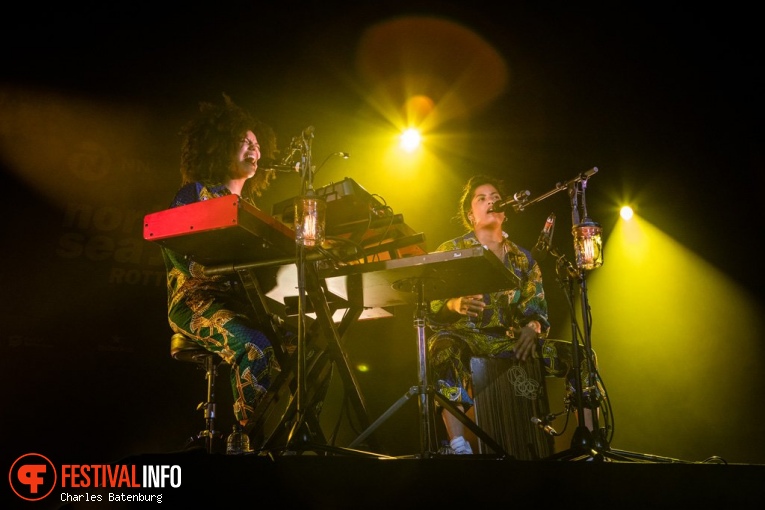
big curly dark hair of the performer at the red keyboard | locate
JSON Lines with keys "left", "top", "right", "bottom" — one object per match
{"left": 180, "top": 94, "right": 276, "bottom": 199}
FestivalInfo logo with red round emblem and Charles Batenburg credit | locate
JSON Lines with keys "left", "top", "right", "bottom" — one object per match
{"left": 8, "top": 453, "right": 181, "bottom": 503}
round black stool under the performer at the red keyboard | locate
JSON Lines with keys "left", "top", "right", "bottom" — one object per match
{"left": 170, "top": 333, "right": 220, "bottom": 453}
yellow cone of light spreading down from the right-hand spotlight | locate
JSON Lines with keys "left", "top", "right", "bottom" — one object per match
{"left": 589, "top": 213, "right": 765, "bottom": 457}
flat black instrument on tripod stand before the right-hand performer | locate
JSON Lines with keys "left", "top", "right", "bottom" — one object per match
{"left": 335, "top": 247, "right": 518, "bottom": 458}
